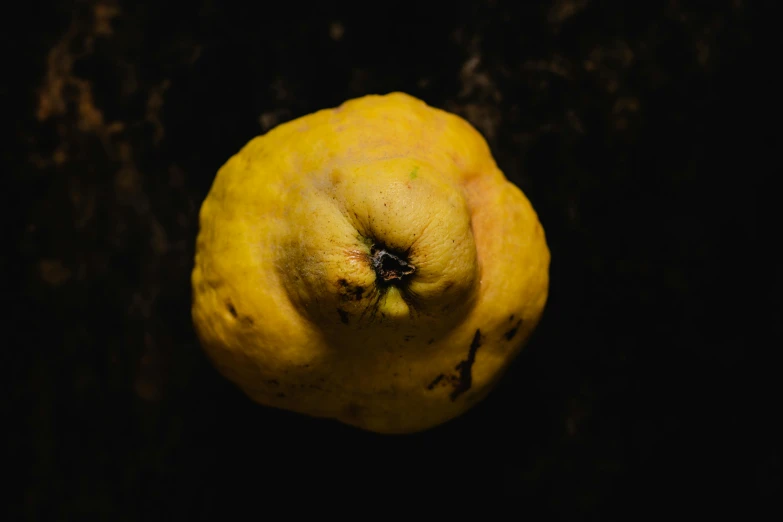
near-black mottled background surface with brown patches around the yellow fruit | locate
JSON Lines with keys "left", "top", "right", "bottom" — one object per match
{"left": 0, "top": 0, "right": 783, "bottom": 521}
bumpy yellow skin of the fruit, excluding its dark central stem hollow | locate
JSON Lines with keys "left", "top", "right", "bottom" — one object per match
{"left": 192, "top": 92, "right": 550, "bottom": 434}
